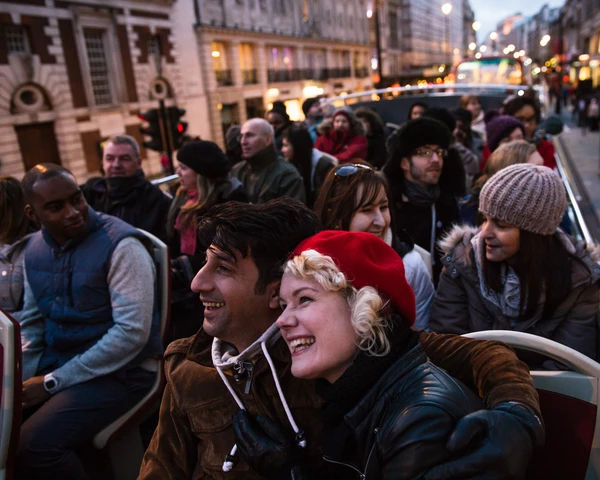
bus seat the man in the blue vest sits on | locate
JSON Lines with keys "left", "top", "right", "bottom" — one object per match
{"left": 93, "top": 229, "right": 171, "bottom": 480}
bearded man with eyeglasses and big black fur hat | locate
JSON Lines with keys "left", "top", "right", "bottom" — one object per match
{"left": 383, "top": 117, "right": 458, "bottom": 283}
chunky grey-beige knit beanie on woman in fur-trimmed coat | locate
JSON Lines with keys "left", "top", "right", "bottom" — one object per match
{"left": 479, "top": 163, "right": 567, "bottom": 235}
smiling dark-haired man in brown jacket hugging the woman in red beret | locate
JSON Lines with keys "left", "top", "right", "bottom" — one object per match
{"left": 139, "top": 199, "right": 544, "bottom": 480}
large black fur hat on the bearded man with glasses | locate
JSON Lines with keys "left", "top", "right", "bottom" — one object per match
{"left": 389, "top": 117, "right": 452, "bottom": 159}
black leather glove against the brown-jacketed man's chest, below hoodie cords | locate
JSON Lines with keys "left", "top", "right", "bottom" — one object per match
{"left": 233, "top": 410, "right": 304, "bottom": 480}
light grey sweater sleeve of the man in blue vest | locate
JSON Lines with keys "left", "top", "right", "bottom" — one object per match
{"left": 52, "top": 237, "right": 156, "bottom": 391}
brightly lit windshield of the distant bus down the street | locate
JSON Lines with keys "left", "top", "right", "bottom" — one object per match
{"left": 456, "top": 57, "right": 523, "bottom": 85}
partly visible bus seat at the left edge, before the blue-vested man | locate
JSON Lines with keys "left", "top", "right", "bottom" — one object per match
{"left": 0, "top": 309, "right": 23, "bottom": 480}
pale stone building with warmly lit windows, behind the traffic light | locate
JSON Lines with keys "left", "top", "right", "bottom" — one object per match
{"left": 188, "top": 0, "right": 372, "bottom": 144}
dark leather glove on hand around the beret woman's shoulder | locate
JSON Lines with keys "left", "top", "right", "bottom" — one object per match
{"left": 425, "top": 402, "right": 545, "bottom": 480}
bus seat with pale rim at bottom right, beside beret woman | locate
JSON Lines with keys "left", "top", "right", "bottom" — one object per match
{"left": 465, "top": 330, "right": 600, "bottom": 480}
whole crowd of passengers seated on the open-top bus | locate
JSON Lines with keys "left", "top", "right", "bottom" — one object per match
{"left": 0, "top": 87, "right": 600, "bottom": 480}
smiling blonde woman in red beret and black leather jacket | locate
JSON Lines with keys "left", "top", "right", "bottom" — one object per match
{"left": 236, "top": 230, "right": 488, "bottom": 479}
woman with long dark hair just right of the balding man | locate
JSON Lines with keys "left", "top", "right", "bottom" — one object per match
{"left": 281, "top": 123, "right": 337, "bottom": 207}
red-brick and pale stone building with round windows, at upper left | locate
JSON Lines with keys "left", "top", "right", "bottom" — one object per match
{"left": 0, "top": 0, "right": 185, "bottom": 181}
